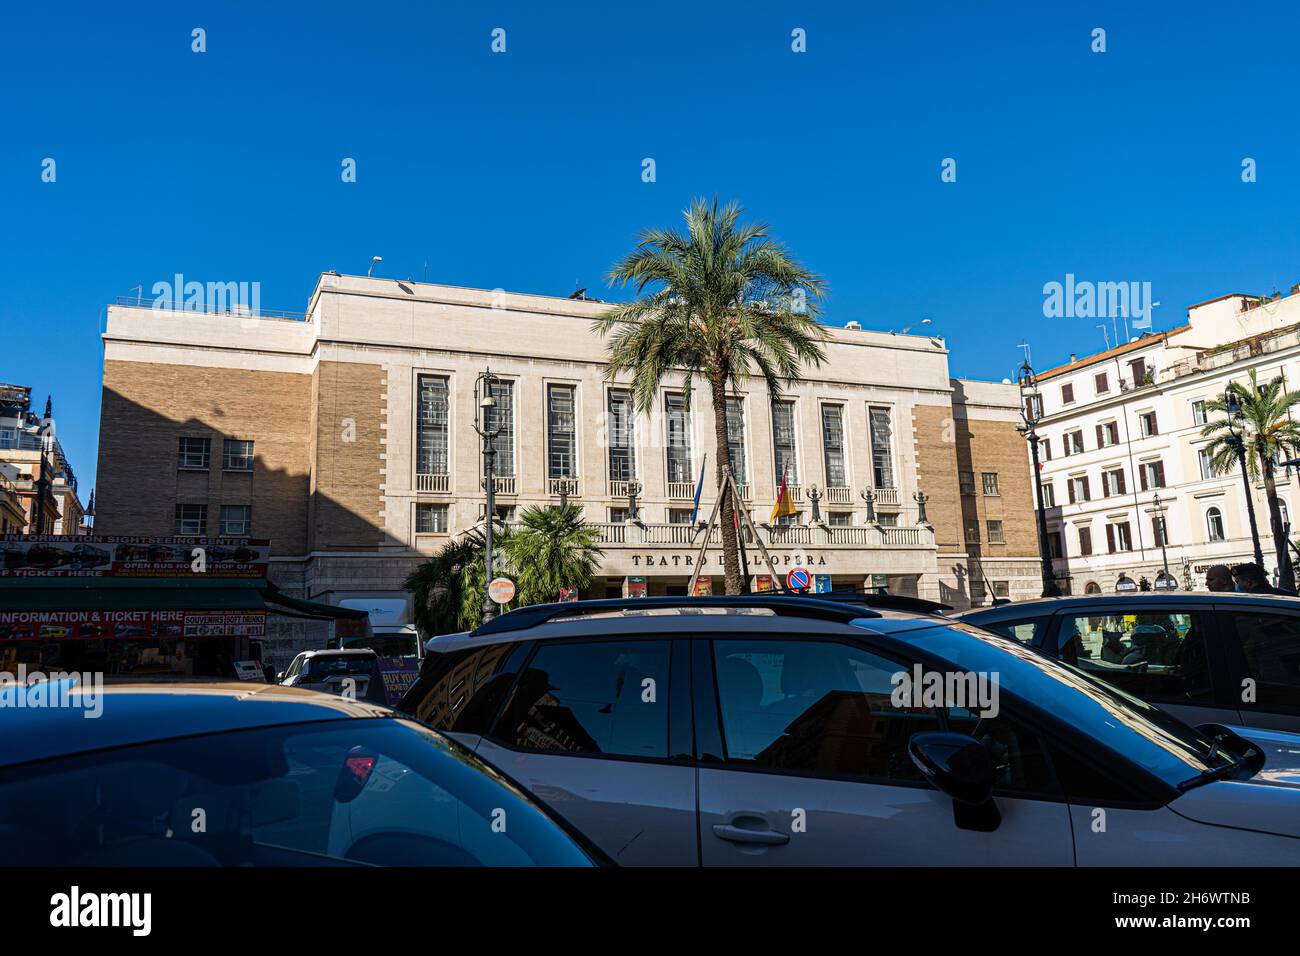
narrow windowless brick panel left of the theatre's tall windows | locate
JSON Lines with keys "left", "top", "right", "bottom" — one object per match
{"left": 313, "top": 362, "right": 387, "bottom": 550}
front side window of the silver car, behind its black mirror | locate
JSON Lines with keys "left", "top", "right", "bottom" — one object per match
{"left": 714, "top": 640, "right": 941, "bottom": 782}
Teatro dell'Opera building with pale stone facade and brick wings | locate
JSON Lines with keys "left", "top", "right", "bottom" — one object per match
{"left": 96, "top": 273, "right": 1039, "bottom": 624}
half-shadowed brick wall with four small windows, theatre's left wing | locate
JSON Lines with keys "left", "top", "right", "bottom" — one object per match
{"left": 95, "top": 360, "right": 311, "bottom": 554}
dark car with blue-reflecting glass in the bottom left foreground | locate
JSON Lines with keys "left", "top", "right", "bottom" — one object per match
{"left": 0, "top": 683, "right": 601, "bottom": 868}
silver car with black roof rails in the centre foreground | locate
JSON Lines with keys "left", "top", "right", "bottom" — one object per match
{"left": 399, "top": 594, "right": 1300, "bottom": 866}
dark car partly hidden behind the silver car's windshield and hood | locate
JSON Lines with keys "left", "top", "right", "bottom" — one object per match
{"left": 958, "top": 592, "right": 1300, "bottom": 732}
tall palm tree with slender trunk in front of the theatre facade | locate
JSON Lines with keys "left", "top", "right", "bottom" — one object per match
{"left": 595, "top": 196, "right": 826, "bottom": 594}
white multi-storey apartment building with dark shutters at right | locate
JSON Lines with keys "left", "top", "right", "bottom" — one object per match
{"left": 1030, "top": 289, "right": 1300, "bottom": 593}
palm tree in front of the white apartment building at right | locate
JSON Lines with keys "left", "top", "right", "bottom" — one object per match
{"left": 1201, "top": 369, "right": 1300, "bottom": 592}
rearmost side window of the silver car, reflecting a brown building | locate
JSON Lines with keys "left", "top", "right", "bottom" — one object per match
{"left": 400, "top": 644, "right": 517, "bottom": 734}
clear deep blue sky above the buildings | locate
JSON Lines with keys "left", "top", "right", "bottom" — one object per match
{"left": 0, "top": 0, "right": 1300, "bottom": 494}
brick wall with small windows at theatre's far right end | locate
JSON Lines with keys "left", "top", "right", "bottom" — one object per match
{"left": 957, "top": 418, "right": 1039, "bottom": 558}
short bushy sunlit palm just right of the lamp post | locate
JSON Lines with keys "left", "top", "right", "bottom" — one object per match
{"left": 502, "top": 503, "right": 602, "bottom": 605}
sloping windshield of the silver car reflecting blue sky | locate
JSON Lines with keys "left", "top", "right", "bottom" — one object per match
{"left": 858, "top": 619, "right": 1243, "bottom": 787}
